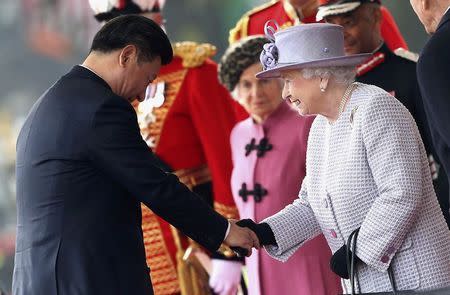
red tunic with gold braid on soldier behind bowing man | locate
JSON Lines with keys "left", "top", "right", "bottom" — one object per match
{"left": 135, "top": 43, "right": 237, "bottom": 294}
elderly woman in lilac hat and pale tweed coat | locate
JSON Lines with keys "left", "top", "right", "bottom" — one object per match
{"left": 239, "top": 24, "right": 450, "bottom": 294}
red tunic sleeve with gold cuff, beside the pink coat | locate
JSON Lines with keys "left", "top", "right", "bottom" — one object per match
{"left": 184, "top": 60, "right": 239, "bottom": 218}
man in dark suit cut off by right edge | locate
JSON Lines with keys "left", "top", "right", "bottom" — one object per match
{"left": 410, "top": 0, "right": 450, "bottom": 222}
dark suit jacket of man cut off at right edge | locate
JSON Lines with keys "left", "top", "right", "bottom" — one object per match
{"left": 417, "top": 11, "right": 450, "bottom": 210}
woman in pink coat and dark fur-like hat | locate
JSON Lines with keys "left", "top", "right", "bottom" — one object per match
{"left": 219, "top": 36, "right": 342, "bottom": 295}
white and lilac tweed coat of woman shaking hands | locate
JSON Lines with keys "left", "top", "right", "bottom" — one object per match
{"left": 263, "top": 83, "right": 450, "bottom": 292}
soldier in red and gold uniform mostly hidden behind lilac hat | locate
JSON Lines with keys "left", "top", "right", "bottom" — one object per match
{"left": 229, "top": 0, "right": 408, "bottom": 120}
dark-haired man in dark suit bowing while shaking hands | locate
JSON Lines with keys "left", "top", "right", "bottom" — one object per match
{"left": 13, "top": 15, "right": 259, "bottom": 295}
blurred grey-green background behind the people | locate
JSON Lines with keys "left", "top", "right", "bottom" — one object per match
{"left": 0, "top": 0, "right": 427, "bottom": 292}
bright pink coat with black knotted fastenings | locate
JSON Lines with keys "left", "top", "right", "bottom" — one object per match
{"left": 231, "top": 102, "right": 341, "bottom": 295}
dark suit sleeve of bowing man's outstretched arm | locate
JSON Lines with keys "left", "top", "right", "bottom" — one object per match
{"left": 89, "top": 96, "right": 228, "bottom": 251}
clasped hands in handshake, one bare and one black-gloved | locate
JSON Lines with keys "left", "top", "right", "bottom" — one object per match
{"left": 224, "top": 219, "right": 276, "bottom": 257}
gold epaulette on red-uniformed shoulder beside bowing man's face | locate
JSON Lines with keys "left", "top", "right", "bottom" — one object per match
{"left": 173, "top": 41, "right": 217, "bottom": 68}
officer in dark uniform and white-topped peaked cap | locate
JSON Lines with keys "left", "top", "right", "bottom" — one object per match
{"left": 318, "top": 0, "right": 449, "bottom": 229}
